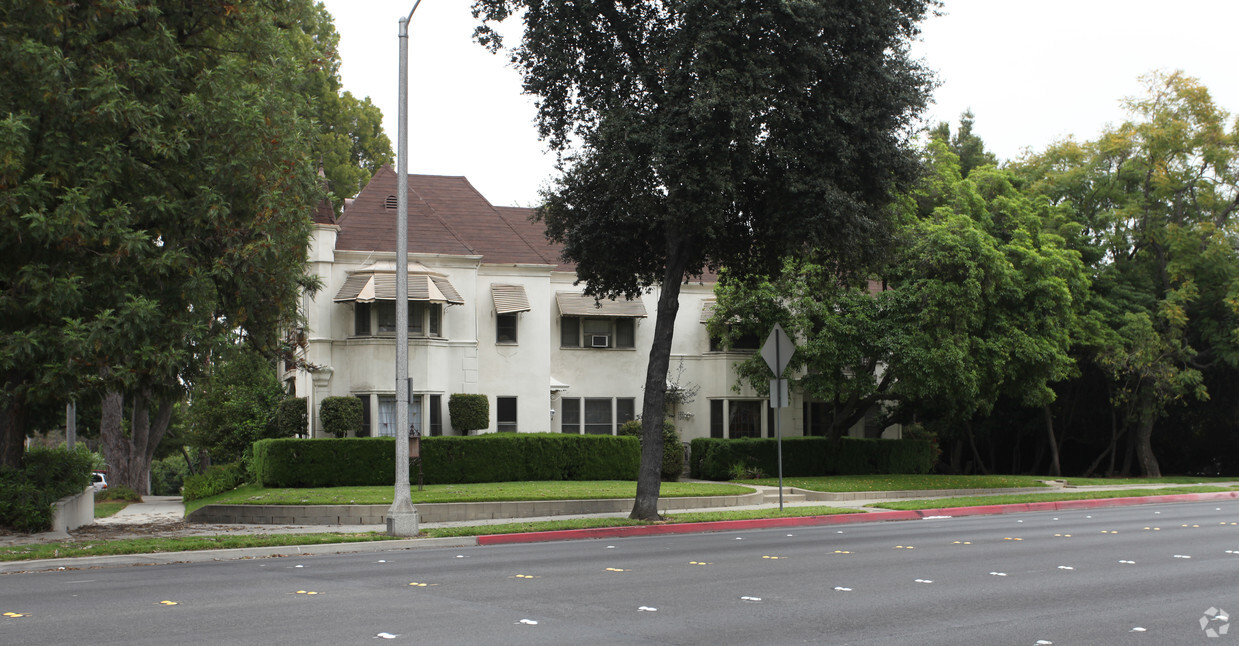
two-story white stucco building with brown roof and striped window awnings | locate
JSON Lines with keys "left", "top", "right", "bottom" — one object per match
{"left": 282, "top": 167, "right": 898, "bottom": 441}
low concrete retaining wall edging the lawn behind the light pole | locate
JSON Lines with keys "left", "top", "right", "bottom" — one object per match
{"left": 186, "top": 491, "right": 764, "bottom": 524}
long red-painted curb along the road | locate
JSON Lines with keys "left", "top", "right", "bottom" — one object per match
{"left": 477, "top": 491, "right": 1239, "bottom": 546}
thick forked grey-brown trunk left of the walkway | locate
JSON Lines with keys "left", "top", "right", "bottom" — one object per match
{"left": 99, "top": 391, "right": 172, "bottom": 496}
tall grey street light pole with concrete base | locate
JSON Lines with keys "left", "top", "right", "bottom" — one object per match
{"left": 387, "top": 0, "right": 421, "bottom": 536}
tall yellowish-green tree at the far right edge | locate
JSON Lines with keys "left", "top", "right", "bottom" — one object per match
{"left": 1020, "top": 72, "right": 1239, "bottom": 476}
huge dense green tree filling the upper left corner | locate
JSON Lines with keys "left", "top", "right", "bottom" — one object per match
{"left": 0, "top": 0, "right": 354, "bottom": 491}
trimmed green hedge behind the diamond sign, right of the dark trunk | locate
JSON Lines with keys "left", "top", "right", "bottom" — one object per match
{"left": 689, "top": 438, "right": 934, "bottom": 480}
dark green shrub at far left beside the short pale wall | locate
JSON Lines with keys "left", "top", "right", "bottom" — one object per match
{"left": 0, "top": 448, "right": 94, "bottom": 532}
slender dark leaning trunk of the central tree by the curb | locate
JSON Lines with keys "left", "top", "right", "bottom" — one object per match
{"left": 628, "top": 247, "right": 684, "bottom": 521}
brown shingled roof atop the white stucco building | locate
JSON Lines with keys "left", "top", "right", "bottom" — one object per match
{"left": 336, "top": 166, "right": 558, "bottom": 264}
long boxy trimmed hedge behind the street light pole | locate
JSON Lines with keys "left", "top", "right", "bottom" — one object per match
{"left": 253, "top": 433, "right": 641, "bottom": 487}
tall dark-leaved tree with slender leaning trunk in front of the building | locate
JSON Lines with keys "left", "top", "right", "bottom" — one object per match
{"left": 473, "top": 0, "right": 937, "bottom": 518}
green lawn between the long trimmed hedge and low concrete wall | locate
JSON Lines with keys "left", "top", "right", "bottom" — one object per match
{"left": 185, "top": 480, "right": 753, "bottom": 513}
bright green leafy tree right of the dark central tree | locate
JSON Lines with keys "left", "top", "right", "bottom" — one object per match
{"left": 710, "top": 138, "right": 1089, "bottom": 473}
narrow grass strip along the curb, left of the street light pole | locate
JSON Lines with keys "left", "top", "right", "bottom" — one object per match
{"left": 0, "top": 532, "right": 396, "bottom": 562}
